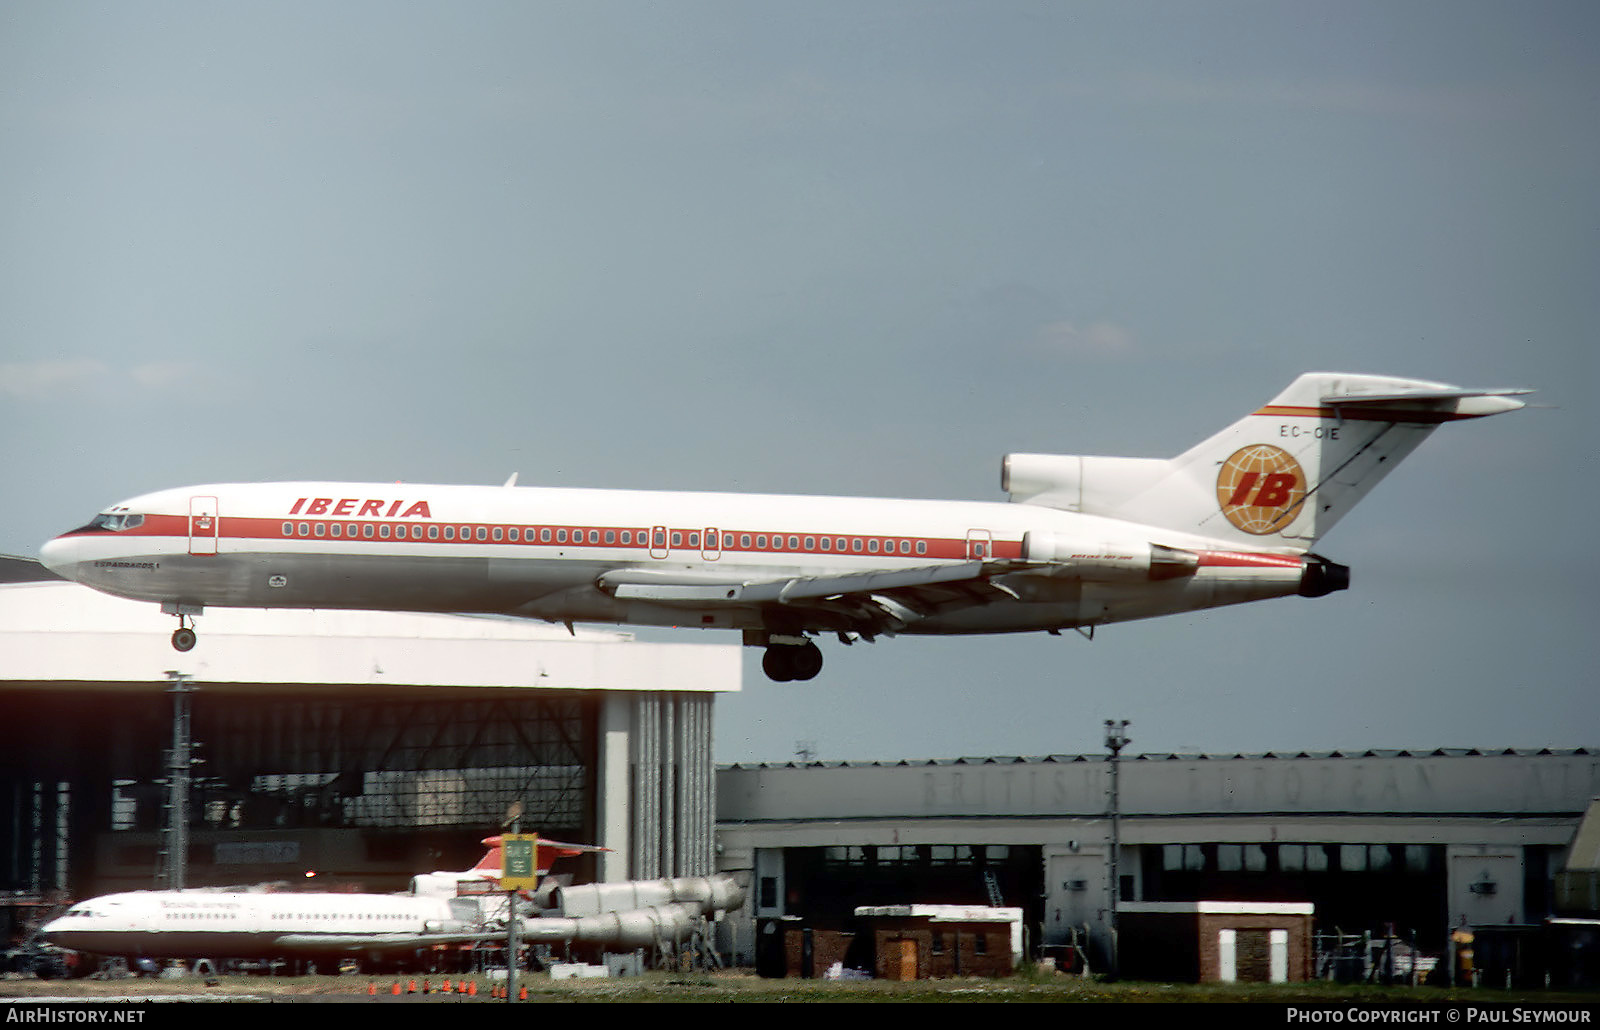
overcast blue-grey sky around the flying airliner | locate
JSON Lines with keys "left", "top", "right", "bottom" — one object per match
{"left": 0, "top": 0, "right": 1600, "bottom": 761}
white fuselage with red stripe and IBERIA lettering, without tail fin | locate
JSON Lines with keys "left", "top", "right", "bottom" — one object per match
{"left": 43, "top": 483, "right": 1306, "bottom": 633}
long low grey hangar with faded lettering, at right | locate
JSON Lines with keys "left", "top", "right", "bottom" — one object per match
{"left": 717, "top": 749, "right": 1600, "bottom": 968}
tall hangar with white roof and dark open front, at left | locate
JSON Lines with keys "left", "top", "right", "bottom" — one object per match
{"left": 0, "top": 558, "right": 741, "bottom": 899}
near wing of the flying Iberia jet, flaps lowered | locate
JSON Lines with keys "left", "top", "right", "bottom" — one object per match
{"left": 600, "top": 561, "right": 1016, "bottom": 637}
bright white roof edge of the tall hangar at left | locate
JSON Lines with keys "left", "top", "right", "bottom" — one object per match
{"left": 0, "top": 575, "right": 741, "bottom": 693}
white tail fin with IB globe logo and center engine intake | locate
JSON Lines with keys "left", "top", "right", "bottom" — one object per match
{"left": 1005, "top": 373, "right": 1530, "bottom": 550}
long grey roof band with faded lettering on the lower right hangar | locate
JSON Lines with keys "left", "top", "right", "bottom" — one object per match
{"left": 717, "top": 747, "right": 1600, "bottom": 815}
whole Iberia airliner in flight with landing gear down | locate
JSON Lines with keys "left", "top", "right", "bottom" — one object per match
{"left": 43, "top": 373, "right": 1528, "bottom": 680}
